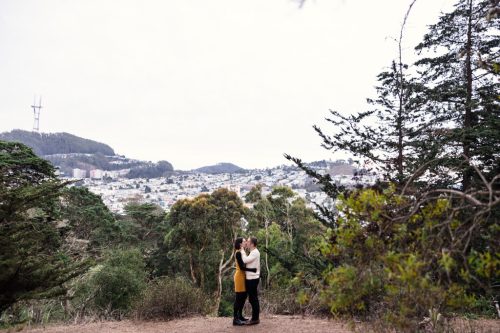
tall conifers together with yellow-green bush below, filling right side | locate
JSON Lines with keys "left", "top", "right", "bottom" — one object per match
{"left": 286, "top": 0, "right": 500, "bottom": 326}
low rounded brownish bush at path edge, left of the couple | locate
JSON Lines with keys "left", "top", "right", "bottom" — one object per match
{"left": 135, "top": 277, "right": 209, "bottom": 319}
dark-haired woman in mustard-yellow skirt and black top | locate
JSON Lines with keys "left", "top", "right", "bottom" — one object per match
{"left": 233, "top": 237, "right": 257, "bottom": 326}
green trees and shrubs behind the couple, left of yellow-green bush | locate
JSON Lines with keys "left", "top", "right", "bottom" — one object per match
{"left": 0, "top": 141, "right": 325, "bottom": 325}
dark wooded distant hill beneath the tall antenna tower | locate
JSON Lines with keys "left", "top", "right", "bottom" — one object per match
{"left": 0, "top": 130, "right": 115, "bottom": 156}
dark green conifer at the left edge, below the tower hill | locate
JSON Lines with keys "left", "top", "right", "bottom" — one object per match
{"left": 0, "top": 141, "right": 87, "bottom": 312}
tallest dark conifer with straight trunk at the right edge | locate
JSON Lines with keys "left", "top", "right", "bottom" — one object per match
{"left": 416, "top": 0, "right": 500, "bottom": 191}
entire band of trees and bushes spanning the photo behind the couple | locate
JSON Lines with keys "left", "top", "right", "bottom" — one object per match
{"left": 0, "top": 0, "right": 500, "bottom": 332}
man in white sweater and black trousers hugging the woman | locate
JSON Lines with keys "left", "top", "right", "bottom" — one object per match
{"left": 241, "top": 237, "right": 260, "bottom": 325}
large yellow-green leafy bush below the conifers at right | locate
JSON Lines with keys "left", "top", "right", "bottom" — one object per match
{"left": 321, "top": 187, "right": 500, "bottom": 329}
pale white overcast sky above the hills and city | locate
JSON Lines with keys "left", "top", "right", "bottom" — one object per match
{"left": 0, "top": 0, "right": 454, "bottom": 170}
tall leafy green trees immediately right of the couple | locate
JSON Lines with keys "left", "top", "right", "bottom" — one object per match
{"left": 246, "top": 186, "right": 326, "bottom": 314}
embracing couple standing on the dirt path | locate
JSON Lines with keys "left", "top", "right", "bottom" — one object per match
{"left": 233, "top": 237, "right": 260, "bottom": 326}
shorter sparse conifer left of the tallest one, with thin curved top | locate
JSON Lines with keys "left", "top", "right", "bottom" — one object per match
{"left": 286, "top": 1, "right": 423, "bottom": 183}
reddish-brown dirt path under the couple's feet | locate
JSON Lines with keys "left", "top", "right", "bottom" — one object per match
{"left": 7, "top": 316, "right": 351, "bottom": 333}
